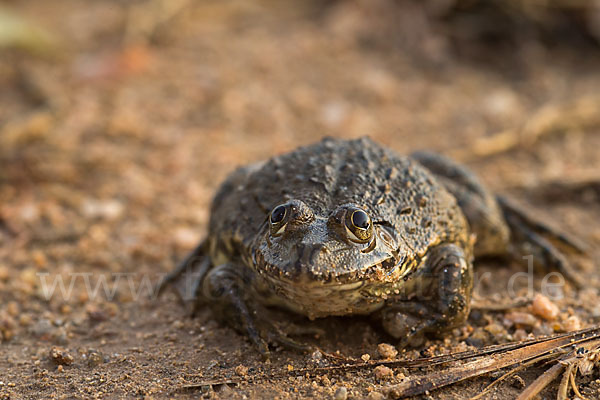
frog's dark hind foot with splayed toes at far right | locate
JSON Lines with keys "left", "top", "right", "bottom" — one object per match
{"left": 498, "top": 196, "right": 587, "bottom": 287}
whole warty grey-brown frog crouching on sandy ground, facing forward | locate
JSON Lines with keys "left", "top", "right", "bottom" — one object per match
{"left": 161, "top": 137, "right": 585, "bottom": 358}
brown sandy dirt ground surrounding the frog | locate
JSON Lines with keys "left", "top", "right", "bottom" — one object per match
{"left": 0, "top": 0, "right": 600, "bottom": 399}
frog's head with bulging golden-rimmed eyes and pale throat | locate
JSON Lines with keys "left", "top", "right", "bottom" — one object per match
{"left": 253, "top": 200, "right": 408, "bottom": 316}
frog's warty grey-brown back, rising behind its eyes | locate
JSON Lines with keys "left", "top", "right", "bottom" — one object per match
{"left": 210, "top": 138, "right": 468, "bottom": 256}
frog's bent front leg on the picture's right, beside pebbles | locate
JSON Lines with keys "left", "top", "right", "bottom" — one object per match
{"left": 380, "top": 244, "right": 473, "bottom": 345}
